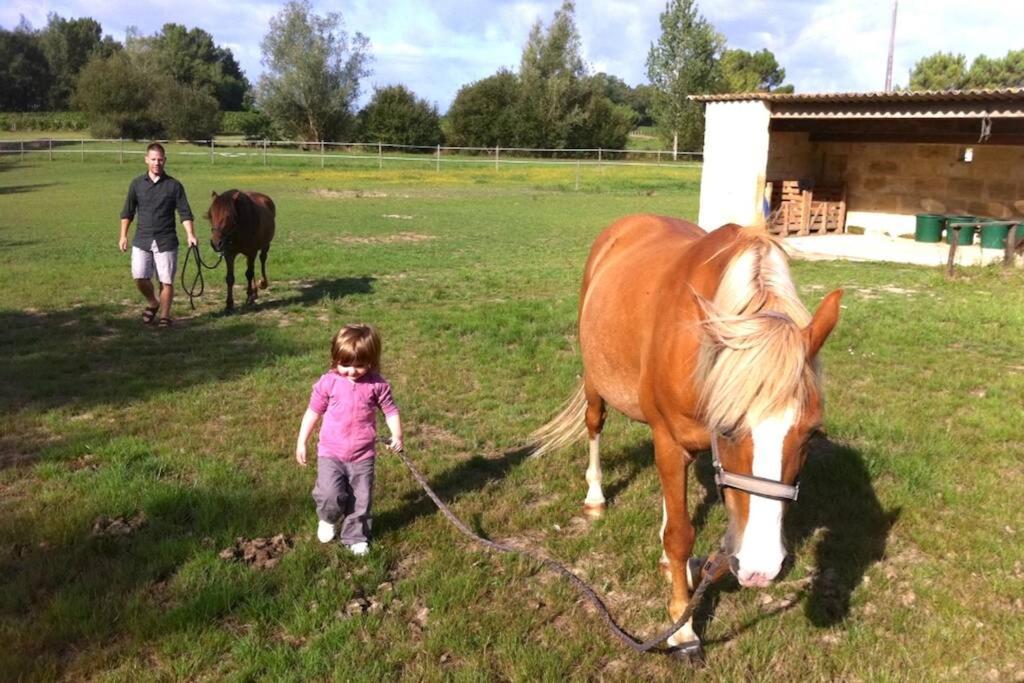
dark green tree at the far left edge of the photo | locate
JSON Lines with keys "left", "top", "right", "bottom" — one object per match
{"left": 0, "top": 26, "right": 53, "bottom": 112}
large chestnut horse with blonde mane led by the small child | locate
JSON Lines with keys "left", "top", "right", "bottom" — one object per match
{"left": 534, "top": 215, "right": 842, "bottom": 655}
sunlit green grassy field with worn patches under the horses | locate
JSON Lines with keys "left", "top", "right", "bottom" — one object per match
{"left": 0, "top": 148, "right": 1024, "bottom": 681}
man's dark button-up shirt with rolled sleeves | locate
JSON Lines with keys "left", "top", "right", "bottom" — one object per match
{"left": 121, "top": 173, "right": 193, "bottom": 251}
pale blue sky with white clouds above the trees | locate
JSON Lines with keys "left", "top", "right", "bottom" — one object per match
{"left": 0, "top": 0, "right": 1024, "bottom": 113}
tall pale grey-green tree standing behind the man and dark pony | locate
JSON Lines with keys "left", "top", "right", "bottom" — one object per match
{"left": 257, "top": 0, "right": 370, "bottom": 140}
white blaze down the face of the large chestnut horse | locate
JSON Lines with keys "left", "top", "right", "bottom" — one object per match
{"left": 736, "top": 408, "right": 796, "bottom": 588}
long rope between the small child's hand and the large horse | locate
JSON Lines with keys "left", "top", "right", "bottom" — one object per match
{"left": 392, "top": 444, "right": 729, "bottom": 652}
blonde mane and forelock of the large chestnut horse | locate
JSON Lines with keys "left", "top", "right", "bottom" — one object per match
{"left": 694, "top": 230, "right": 818, "bottom": 435}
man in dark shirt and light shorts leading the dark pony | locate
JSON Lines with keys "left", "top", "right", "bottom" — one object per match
{"left": 119, "top": 142, "right": 197, "bottom": 328}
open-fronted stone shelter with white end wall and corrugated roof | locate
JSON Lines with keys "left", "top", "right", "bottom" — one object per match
{"left": 692, "top": 88, "right": 1024, "bottom": 237}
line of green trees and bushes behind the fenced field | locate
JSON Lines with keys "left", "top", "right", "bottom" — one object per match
{"left": 0, "top": 0, "right": 793, "bottom": 151}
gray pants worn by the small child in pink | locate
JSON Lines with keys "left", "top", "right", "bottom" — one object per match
{"left": 313, "top": 458, "right": 377, "bottom": 546}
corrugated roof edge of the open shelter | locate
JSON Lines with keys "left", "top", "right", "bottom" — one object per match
{"left": 690, "top": 88, "right": 1024, "bottom": 104}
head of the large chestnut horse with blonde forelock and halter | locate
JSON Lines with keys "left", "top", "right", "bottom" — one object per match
{"left": 698, "top": 290, "right": 842, "bottom": 587}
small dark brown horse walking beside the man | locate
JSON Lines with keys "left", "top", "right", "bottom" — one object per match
{"left": 206, "top": 189, "right": 278, "bottom": 310}
